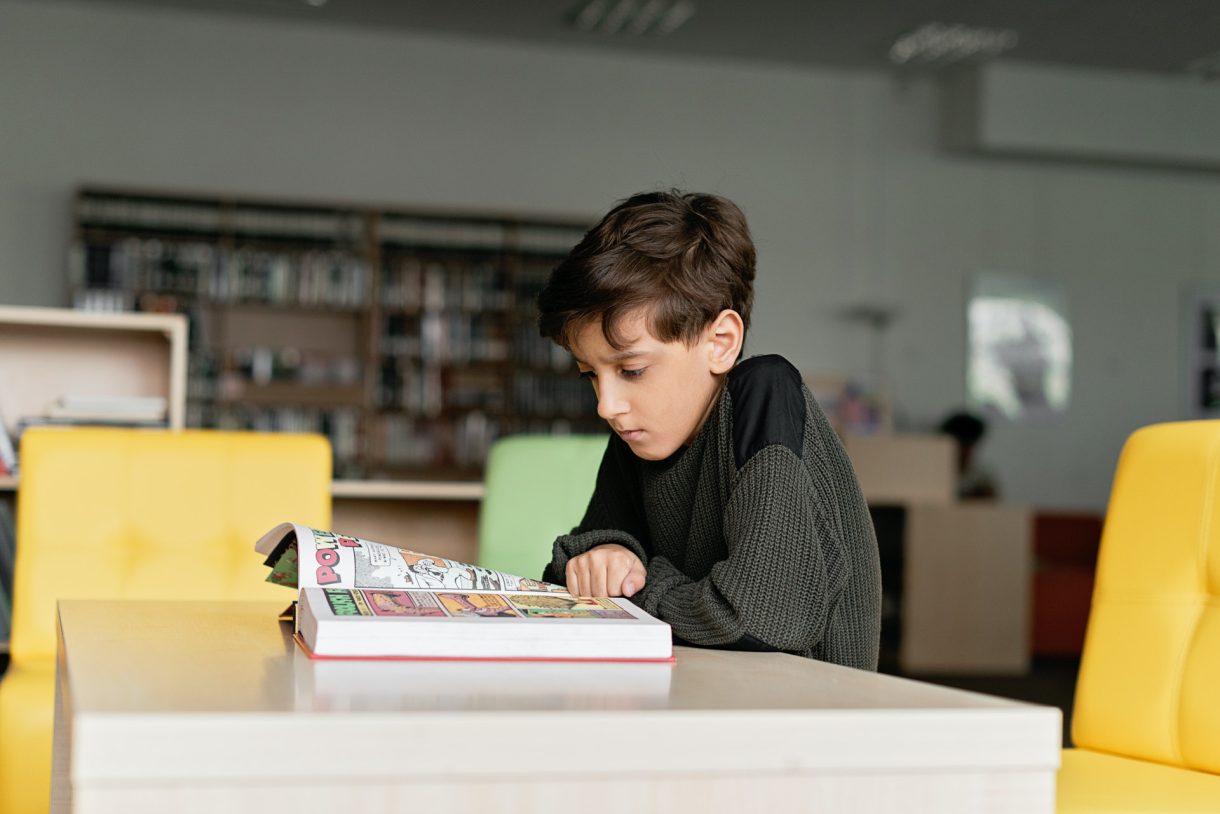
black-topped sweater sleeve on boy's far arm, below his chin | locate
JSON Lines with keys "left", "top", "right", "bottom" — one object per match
{"left": 542, "top": 436, "right": 649, "bottom": 585}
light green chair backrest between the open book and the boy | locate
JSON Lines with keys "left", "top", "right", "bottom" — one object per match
{"left": 478, "top": 434, "right": 609, "bottom": 578}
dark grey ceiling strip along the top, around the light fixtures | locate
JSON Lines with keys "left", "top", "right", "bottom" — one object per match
{"left": 57, "top": 0, "right": 1220, "bottom": 77}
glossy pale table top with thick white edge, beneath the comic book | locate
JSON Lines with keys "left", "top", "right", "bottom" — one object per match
{"left": 60, "top": 600, "right": 1061, "bottom": 780}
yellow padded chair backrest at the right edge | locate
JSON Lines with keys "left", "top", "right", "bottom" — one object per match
{"left": 1072, "top": 421, "right": 1220, "bottom": 773}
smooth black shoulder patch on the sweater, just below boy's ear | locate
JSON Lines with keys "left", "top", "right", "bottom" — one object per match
{"left": 728, "top": 355, "right": 805, "bottom": 469}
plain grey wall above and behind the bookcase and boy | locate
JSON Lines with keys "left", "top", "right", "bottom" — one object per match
{"left": 0, "top": 0, "right": 1220, "bottom": 509}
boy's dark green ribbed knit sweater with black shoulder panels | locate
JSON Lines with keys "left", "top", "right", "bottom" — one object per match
{"left": 543, "top": 356, "right": 881, "bottom": 670}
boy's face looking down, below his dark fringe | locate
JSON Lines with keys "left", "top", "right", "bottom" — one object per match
{"left": 572, "top": 311, "right": 741, "bottom": 460}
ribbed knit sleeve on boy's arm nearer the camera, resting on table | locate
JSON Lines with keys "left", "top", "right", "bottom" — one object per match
{"left": 632, "top": 444, "right": 849, "bottom": 650}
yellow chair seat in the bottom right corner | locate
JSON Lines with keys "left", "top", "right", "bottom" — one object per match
{"left": 1055, "top": 749, "right": 1220, "bottom": 814}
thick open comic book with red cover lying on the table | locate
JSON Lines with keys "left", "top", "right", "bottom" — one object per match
{"left": 255, "top": 524, "right": 672, "bottom": 660}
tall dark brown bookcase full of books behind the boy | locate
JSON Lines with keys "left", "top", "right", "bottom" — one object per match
{"left": 70, "top": 187, "right": 600, "bottom": 481}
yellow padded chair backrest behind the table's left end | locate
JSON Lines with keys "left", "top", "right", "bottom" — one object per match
{"left": 12, "top": 427, "right": 331, "bottom": 664}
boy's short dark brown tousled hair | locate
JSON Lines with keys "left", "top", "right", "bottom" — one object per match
{"left": 538, "top": 189, "right": 754, "bottom": 349}
